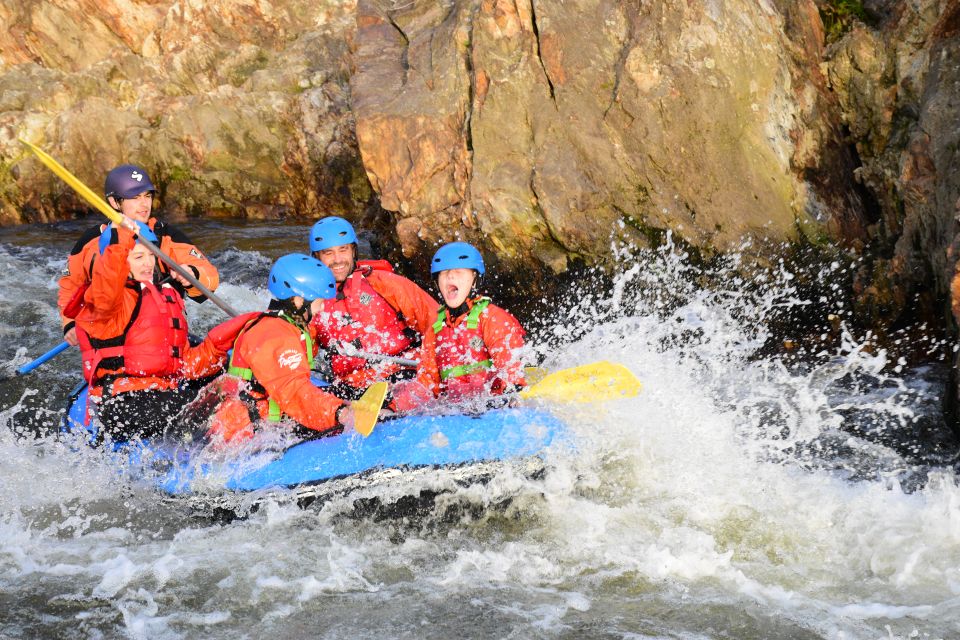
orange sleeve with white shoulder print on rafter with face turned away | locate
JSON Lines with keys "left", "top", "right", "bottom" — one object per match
{"left": 236, "top": 318, "right": 345, "bottom": 431}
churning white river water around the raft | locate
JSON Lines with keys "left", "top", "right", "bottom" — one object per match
{"left": 0, "top": 222, "right": 960, "bottom": 640}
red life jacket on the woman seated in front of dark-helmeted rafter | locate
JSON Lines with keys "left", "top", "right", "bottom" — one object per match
{"left": 77, "top": 282, "right": 188, "bottom": 386}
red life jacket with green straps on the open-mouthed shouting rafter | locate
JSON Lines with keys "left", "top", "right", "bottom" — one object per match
{"left": 433, "top": 298, "right": 493, "bottom": 397}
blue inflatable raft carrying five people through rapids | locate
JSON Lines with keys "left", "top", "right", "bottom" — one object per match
{"left": 64, "top": 388, "right": 566, "bottom": 495}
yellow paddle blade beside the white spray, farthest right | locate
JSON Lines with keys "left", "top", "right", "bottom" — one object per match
{"left": 520, "top": 361, "right": 640, "bottom": 402}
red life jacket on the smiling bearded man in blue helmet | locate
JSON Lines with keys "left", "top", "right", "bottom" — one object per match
{"left": 315, "top": 261, "right": 416, "bottom": 378}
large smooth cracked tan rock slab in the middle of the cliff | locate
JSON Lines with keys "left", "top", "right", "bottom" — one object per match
{"left": 351, "top": 0, "right": 865, "bottom": 271}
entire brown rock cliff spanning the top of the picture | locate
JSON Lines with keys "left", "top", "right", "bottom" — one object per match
{"left": 0, "top": 0, "right": 960, "bottom": 340}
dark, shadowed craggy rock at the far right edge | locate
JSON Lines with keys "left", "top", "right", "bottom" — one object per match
{"left": 827, "top": 0, "right": 960, "bottom": 325}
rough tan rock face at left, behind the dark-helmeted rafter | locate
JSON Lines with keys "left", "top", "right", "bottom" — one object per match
{"left": 0, "top": 0, "right": 373, "bottom": 223}
